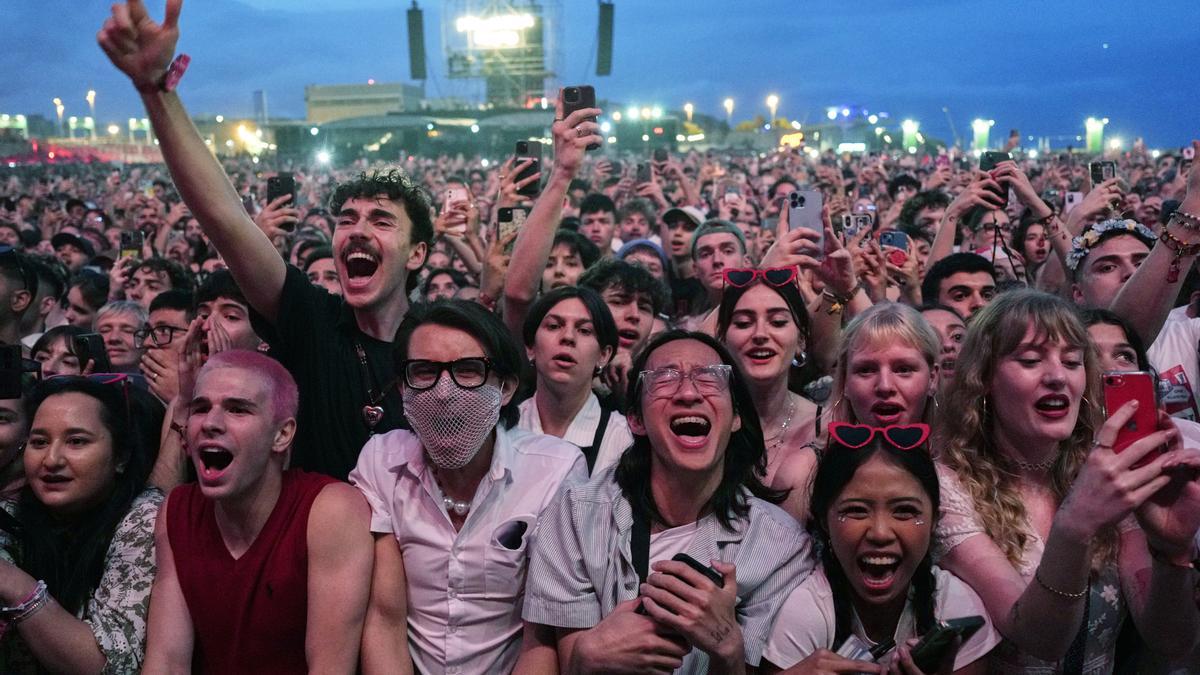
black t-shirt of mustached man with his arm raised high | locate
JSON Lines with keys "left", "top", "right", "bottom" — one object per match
{"left": 251, "top": 265, "right": 407, "bottom": 480}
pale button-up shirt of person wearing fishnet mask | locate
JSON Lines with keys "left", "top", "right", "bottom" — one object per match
{"left": 350, "top": 426, "right": 587, "bottom": 675}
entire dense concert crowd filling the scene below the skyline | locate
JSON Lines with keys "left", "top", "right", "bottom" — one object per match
{"left": 0, "top": 0, "right": 1200, "bottom": 675}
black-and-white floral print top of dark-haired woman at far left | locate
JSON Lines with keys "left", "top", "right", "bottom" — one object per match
{"left": 0, "top": 489, "right": 163, "bottom": 674}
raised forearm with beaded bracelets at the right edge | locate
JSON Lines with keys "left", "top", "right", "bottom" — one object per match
{"left": 1109, "top": 141, "right": 1200, "bottom": 345}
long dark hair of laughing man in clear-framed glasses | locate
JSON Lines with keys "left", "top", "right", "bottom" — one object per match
{"left": 616, "top": 330, "right": 788, "bottom": 530}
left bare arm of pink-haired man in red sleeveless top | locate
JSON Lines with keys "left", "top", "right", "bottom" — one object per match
{"left": 142, "top": 492, "right": 194, "bottom": 674}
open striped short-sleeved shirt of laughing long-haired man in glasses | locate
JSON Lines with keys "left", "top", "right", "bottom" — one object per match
{"left": 522, "top": 467, "right": 814, "bottom": 673}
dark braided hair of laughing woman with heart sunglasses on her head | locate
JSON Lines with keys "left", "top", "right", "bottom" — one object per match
{"left": 809, "top": 434, "right": 941, "bottom": 645}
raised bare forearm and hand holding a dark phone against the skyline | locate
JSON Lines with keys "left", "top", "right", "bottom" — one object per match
{"left": 504, "top": 92, "right": 604, "bottom": 335}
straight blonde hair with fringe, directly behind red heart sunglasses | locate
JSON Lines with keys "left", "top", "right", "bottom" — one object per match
{"left": 826, "top": 303, "right": 942, "bottom": 428}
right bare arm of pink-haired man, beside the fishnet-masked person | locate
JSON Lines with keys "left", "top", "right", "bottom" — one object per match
{"left": 305, "top": 483, "right": 374, "bottom": 673}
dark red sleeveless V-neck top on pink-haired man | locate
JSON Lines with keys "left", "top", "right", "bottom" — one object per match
{"left": 167, "top": 470, "right": 336, "bottom": 674}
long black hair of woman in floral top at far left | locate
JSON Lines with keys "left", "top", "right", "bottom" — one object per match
{"left": 0, "top": 376, "right": 149, "bottom": 614}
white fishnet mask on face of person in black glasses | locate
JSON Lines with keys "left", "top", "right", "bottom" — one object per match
{"left": 403, "top": 376, "right": 503, "bottom": 468}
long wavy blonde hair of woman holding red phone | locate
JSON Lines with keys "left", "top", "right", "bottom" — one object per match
{"left": 932, "top": 289, "right": 1117, "bottom": 566}
